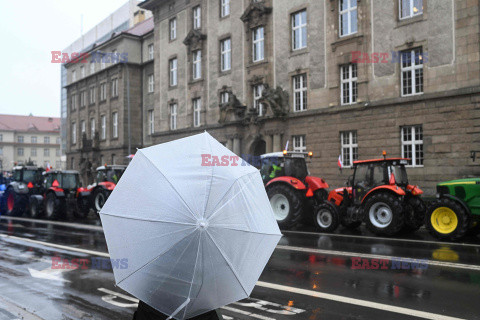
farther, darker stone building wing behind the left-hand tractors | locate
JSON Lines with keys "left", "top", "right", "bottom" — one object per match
{"left": 66, "top": 18, "right": 154, "bottom": 184}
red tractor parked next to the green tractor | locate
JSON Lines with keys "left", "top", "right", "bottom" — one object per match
{"left": 324, "top": 152, "right": 426, "bottom": 236}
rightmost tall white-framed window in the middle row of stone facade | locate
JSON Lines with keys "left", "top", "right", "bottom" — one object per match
{"left": 401, "top": 48, "right": 423, "bottom": 97}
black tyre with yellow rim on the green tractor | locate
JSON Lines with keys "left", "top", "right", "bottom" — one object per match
{"left": 425, "top": 198, "right": 469, "bottom": 240}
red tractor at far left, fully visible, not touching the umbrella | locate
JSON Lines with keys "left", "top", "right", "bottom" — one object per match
{"left": 29, "top": 170, "right": 90, "bottom": 220}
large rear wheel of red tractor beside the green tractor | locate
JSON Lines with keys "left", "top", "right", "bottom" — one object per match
{"left": 364, "top": 193, "right": 405, "bottom": 236}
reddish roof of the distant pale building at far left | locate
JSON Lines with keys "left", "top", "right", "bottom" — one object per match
{"left": 0, "top": 114, "right": 60, "bottom": 132}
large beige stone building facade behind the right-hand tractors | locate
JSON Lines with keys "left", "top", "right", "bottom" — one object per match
{"left": 64, "top": 0, "right": 480, "bottom": 194}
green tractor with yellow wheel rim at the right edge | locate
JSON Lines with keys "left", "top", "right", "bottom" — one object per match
{"left": 425, "top": 178, "right": 480, "bottom": 240}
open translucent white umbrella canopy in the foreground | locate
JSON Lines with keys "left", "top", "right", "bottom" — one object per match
{"left": 100, "top": 132, "right": 281, "bottom": 319}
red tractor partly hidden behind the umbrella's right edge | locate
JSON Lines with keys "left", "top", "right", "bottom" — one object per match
{"left": 260, "top": 151, "right": 332, "bottom": 229}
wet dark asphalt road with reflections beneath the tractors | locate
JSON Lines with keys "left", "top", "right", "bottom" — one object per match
{"left": 0, "top": 217, "right": 480, "bottom": 320}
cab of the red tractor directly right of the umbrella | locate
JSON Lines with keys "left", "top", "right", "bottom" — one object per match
{"left": 260, "top": 151, "right": 313, "bottom": 184}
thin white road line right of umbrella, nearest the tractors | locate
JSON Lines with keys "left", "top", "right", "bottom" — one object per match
{"left": 277, "top": 246, "right": 480, "bottom": 271}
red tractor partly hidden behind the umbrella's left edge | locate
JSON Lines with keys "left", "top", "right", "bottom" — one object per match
{"left": 88, "top": 165, "right": 127, "bottom": 214}
